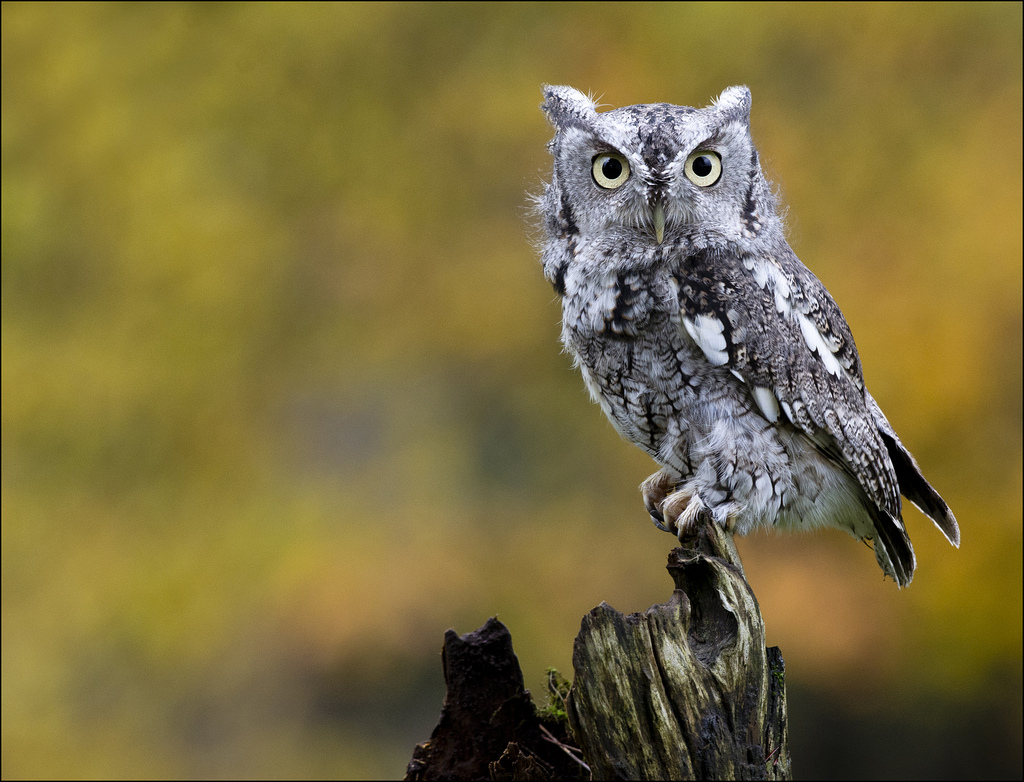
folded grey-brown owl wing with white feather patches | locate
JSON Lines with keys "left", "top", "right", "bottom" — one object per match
{"left": 674, "top": 247, "right": 912, "bottom": 524}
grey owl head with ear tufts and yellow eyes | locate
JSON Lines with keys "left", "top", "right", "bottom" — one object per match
{"left": 541, "top": 86, "right": 778, "bottom": 256}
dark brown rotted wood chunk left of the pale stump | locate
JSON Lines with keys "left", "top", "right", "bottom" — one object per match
{"left": 406, "top": 618, "right": 587, "bottom": 780}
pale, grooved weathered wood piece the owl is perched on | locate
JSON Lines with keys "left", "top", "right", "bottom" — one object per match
{"left": 567, "top": 525, "right": 791, "bottom": 779}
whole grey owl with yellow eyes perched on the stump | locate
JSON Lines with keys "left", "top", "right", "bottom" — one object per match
{"left": 537, "top": 87, "right": 959, "bottom": 587}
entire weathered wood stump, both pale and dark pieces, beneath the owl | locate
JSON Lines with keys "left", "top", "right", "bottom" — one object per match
{"left": 406, "top": 526, "right": 791, "bottom": 780}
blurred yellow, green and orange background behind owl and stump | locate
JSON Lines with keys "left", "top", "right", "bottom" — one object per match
{"left": 2, "top": 3, "right": 1022, "bottom": 779}
